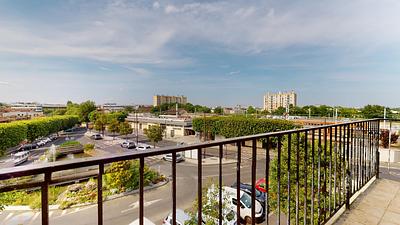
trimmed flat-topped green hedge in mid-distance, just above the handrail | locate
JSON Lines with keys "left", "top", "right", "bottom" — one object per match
{"left": 193, "top": 116, "right": 299, "bottom": 138}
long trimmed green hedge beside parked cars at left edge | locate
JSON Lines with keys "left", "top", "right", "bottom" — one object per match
{"left": 0, "top": 116, "right": 78, "bottom": 155}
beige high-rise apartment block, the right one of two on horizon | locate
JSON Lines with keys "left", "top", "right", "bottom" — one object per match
{"left": 264, "top": 91, "right": 297, "bottom": 112}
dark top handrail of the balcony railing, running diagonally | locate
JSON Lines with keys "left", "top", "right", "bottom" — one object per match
{"left": 0, "top": 119, "right": 382, "bottom": 180}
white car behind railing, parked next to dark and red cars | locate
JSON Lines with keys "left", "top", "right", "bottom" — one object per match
{"left": 222, "top": 187, "right": 265, "bottom": 224}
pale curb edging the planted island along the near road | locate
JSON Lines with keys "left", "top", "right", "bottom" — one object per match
{"left": 3, "top": 178, "right": 169, "bottom": 211}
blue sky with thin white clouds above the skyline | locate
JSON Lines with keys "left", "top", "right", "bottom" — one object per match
{"left": 0, "top": 0, "right": 400, "bottom": 107}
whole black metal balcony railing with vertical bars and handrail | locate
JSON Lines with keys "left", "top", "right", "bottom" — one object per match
{"left": 0, "top": 119, "right": 381, "bottom": 225}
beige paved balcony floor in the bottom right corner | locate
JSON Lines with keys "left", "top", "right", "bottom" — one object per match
{"left": 335, "top": 178, "right": 400, "bottom": 225}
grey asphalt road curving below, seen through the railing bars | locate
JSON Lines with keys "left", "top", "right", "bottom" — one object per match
{"left": 0, "top": 152, "right": 278, "bottom": 225}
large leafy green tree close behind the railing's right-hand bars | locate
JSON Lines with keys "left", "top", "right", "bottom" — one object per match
{"left": 269, "top": 134, "right": 344, "bottom": 224}
